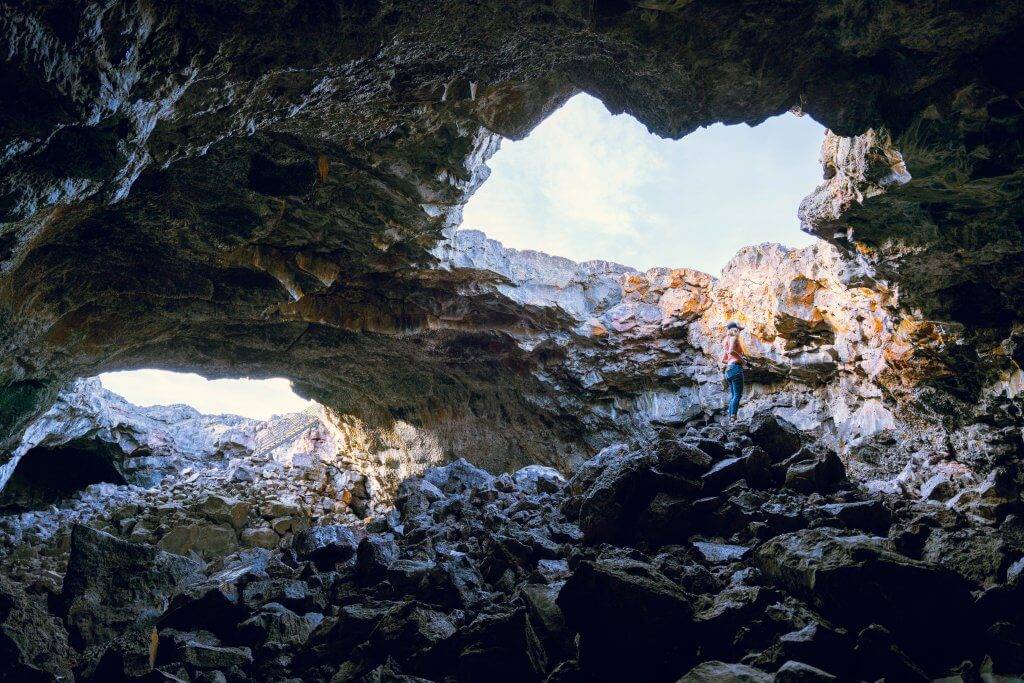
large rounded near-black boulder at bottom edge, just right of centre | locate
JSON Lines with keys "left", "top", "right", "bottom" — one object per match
{"left": 557, "top": 557, "right": 695, "bottom": 679}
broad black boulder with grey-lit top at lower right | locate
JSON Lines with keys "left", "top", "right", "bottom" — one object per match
{"left": 755, "top": 528, "right": 975, "bottom": 670}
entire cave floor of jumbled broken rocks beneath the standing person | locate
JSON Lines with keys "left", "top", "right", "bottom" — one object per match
{"left": 0, "top": 414, "right": 1024, "bottom": 681}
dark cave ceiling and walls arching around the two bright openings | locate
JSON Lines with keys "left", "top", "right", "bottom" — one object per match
{"left": 0, "top": 0, "right": 1024, "bottom": 475}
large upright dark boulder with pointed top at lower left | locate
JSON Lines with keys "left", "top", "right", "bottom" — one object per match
{"left": 60, "top": 524, "right": 203, "bottom": 648}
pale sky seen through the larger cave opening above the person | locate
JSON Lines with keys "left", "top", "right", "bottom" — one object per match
{"left": 462, "top": 94, "right": 825, "bottom": 275}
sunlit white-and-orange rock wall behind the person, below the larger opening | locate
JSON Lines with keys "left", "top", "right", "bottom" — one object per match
{"left": 452, "top": 227, "right": 1021, "bottom": 504}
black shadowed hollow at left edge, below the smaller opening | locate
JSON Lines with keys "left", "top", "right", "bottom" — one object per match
{"left": 0, "top": 438, "right": 128, "bottom": 512}
